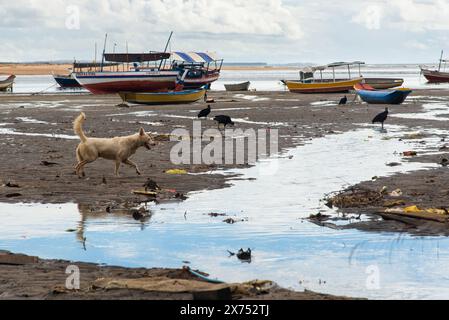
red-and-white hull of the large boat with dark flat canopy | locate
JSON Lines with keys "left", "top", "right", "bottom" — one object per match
{"left": 74, "top": 71, "right": 179, "bottom": 94}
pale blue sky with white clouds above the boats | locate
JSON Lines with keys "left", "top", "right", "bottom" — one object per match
{"left": 0, "top": 0, "right": 449, "bottom": 64}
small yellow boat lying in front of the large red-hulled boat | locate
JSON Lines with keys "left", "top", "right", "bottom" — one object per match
{"left": 119, "top": 89, "right": 206, "bottom": 105}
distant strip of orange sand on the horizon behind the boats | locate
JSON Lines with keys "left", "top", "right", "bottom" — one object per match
{"left": 0, "top": 63, "right": 298, "bottom": 76}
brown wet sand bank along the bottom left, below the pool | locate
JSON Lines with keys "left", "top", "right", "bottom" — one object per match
{"left": 0, "top": 251, "right": 348, "bottom": 300}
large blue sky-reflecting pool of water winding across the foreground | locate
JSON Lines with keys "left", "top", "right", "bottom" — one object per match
{"left": 0, "top": 126, "right": 449, "bottom": 299}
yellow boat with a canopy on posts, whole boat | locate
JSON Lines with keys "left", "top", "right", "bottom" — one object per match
{"left": 283, "top": 61, "right": 365, "bottom": 93}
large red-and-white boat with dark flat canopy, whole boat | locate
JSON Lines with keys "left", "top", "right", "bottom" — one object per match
{"left": 73, "top": 52, "right": 179, "bottom": 94}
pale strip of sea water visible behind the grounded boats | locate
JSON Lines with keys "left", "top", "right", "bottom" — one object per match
{"left": 0, "top": 64, "right": 449, "bottom": 93}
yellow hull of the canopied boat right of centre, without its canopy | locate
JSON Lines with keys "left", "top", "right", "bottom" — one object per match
{"left": 285, "top": 78, "right": 363, "bottom": 93}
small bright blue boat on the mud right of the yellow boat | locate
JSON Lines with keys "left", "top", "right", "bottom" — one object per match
{"left": 354, "top": 84, "right": 412, "bottom": 104}
